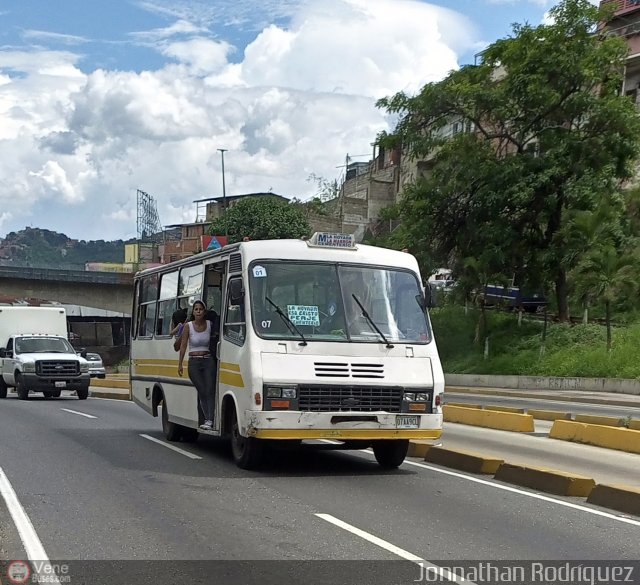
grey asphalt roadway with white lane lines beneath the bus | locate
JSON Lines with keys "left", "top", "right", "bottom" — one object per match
{"left": 0, "top": 397, "right": 640, "bottom": 583}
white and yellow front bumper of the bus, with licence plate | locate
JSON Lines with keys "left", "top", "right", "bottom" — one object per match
{"left": 245, "top": 411, "right": 442, "bottom": 441}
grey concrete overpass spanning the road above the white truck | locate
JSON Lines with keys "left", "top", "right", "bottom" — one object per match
{"left": 0, "top": 266, "right": 133, "bottom": 315}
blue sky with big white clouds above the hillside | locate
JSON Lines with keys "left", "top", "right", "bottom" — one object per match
{"left": 0, "top": 0, "right": 595, "bottom": 240}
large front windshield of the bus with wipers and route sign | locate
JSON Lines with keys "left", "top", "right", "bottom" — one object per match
{"left": 249, "top": 260, "right": 431, "bottom": 343}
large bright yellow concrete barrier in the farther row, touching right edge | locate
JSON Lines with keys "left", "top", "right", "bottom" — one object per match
{"left": 549, "top": 420, "right": 640, "bottom": 453}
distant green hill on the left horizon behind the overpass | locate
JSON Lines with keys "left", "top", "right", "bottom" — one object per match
{"left": 0, "top": 227, "right": 134, "bottom": 268}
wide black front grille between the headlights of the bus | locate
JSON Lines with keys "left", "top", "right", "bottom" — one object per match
{"left": 298, "top": 384, "right": 403, "bottom": 412}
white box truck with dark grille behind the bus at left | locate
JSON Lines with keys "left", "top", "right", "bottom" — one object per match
{"left": 0, "top": 306, "right": 90, "bottom": 400}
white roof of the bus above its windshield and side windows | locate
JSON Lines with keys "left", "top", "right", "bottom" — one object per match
{"left": 136, "top": 239, "right": 418, "bottom": 278}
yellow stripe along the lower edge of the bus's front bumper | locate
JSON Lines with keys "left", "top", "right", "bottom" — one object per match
{"left": 252, "top": 429, "right": 442, "bottom": 440}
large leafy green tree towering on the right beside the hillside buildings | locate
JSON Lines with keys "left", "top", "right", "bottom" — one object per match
{"left": 379, "top": 0, "right": 640, "bottom": 319}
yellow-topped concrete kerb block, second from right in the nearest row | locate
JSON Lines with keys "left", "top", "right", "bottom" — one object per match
{"left": 495, "top": 463, "right": 596, "bottom": 497}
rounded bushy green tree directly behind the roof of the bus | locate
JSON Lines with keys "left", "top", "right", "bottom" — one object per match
{"left": 209, "top": 197, "right": 311, "bottom": 243}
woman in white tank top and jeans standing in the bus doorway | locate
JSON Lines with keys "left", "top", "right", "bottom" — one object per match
{"left": 178, "top": 301, "right": 216, "bottom": 430}
